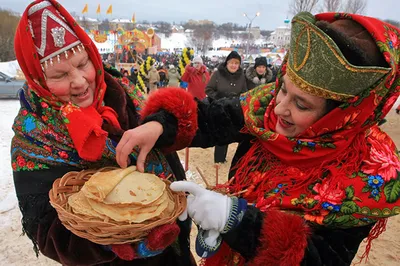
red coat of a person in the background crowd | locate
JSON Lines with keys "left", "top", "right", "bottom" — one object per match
{"left": 182, "top": 65, "right": 210, "bottom": 100}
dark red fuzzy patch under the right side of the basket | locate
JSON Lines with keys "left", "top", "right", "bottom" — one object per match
{"left": 147, "top": 223, "right": 180, "bottom": 251}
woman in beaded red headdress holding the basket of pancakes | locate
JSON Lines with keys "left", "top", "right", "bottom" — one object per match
{"left": 11, "top": 0, "right": 194, "bottom": 266}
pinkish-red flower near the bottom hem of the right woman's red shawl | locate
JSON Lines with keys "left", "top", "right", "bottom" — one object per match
{"left": 313, "top": 182, "right": 346, "bottom": 205}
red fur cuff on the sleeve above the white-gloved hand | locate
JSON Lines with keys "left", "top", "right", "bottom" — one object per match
{"left": 249, "top": 210, "right": 310, "bottom": 266}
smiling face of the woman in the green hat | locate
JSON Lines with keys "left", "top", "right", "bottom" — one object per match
{"left": 274, "top": 75, "right": 326, "bottom": 137}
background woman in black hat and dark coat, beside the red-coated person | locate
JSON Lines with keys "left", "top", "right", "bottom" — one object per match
{"left": 206, "top": 51, "right": 247, "bottom": 163}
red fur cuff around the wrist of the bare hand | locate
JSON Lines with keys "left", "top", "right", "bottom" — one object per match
{"left": 141, "top": 88, "right": 198, "bottom": 152}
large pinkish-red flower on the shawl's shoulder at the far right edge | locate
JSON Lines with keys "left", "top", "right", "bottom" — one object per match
{"left": 361, "top": 137, "right": 400, "bottom": 182}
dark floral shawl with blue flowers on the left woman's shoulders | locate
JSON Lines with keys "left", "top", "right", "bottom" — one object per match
{"left": 11, "top": 77, "right": 172, "bottom": 178}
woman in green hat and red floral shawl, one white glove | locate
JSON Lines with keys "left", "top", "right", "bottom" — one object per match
{"left": 117, "top": 13, "right": 400, "bottom": 265}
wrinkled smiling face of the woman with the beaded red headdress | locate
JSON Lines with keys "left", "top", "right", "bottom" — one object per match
{"left": 44, "top": 50, "right": 96, "bottom": 107}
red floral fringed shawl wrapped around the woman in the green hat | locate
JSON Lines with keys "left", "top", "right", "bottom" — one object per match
{"left": 203, "top": 13, "right": 400, "bottom": 266}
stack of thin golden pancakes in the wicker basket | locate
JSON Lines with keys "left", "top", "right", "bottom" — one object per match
{"left": 68, "top": 166, "right": 175, "bottom": 224}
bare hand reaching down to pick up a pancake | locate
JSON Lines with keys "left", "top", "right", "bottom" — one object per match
{"left": 116, "top": 121, "right": 163, "bottom": 172}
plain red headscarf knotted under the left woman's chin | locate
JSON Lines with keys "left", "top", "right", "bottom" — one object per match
{"left": 14, "top": 0, "right": 121, "bottom": 161}
